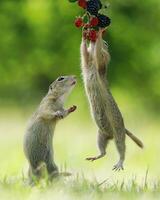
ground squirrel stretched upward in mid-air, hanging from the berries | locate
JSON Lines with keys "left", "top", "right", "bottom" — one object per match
{"left": 81, "top": 30, "right": 143, "bottom": 170}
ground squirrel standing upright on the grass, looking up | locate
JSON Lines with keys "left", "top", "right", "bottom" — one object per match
{"left": 24, "top": 76, "right": 76, "bottom": 179}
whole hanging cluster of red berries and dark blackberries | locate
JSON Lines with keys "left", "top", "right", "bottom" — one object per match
{"left": 69, "top": 0, "right": 111, "bottom": 42}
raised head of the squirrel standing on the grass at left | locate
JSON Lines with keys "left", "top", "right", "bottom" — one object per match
{"left": 48, "top": 75, "right": 76, "bottom": 100}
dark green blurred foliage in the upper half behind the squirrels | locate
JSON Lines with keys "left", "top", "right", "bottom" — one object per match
{"left": 0, "top": 0, "right": 160, "bottom": 111}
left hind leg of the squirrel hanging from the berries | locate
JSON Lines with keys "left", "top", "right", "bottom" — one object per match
{"left": 86, "top": 131, "right": 110, "bottom": 161}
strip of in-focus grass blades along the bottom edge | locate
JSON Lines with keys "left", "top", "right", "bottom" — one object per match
{"left": 0, "top": 174, "right": 160, "bottom": 200}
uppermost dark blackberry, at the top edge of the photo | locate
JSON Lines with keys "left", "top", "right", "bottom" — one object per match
{"left": 87, "top": 0, "right": 101, "bottom": 15}
